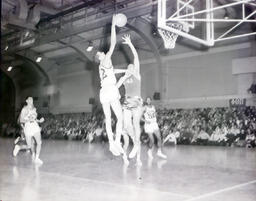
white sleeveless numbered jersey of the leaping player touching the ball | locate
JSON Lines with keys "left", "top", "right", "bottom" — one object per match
{"left": 99, "top": 65, "right": 116, "bottom": 87}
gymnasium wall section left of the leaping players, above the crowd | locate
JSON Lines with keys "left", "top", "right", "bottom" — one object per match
{"left": 51, "top": 62, "right": 94, "bottom": 113}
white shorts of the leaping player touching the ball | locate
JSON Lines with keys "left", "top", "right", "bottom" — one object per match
{"left": 100, "top": 85, "right": 121, "bottom": 103}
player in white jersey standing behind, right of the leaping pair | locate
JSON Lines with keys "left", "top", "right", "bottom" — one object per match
{"left": 144, "top": 97, "right": 167, "bottom": 159}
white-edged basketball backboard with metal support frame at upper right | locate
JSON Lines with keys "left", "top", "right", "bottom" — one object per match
{"left": 157, "top": 0, "right": 256, "bottom": 49}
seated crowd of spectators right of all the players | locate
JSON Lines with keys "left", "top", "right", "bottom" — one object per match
{"left": 158, "top": 107, "right": 256, "bottom": 147}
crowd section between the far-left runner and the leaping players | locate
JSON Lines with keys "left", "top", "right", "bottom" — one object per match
{"left": 41, "top": 113, "right": 106, "bottom": 142}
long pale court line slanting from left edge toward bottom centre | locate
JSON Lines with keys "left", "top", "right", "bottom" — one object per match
{"left": 0, "top": 167, "right": 192, "bottom": 198}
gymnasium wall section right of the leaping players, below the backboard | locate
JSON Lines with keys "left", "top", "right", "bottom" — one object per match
{"left": 142, "top": 43, "right": 256, "bottom": 108}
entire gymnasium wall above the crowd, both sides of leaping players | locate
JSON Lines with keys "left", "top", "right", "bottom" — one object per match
{"left": 47, "top": 43, "right": 255, "bottom": 113}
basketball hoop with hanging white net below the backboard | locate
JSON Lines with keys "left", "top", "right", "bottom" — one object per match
{"left": 158, "top": 22, "right": 189, "bottom": 49}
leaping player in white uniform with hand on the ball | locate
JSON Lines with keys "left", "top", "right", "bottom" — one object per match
{"left": 96, "top": 15, "right": 123, "bottom": 156}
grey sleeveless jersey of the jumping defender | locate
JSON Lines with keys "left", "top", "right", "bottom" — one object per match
{"left": 124, "top": 75, "right": 141, "bottom": 97}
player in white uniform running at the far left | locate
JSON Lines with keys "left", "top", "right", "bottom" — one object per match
{"left": 14, "top": 97, "right": 44, "bottom": 164}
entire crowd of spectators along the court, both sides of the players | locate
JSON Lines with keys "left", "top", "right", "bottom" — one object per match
{"left": 2, "top": 107, "right": 256, "bottom": 147}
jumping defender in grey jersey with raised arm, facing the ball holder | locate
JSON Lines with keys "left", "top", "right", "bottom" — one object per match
{"left": 117, "top": 35, "right": 143, "bottom": 165}
